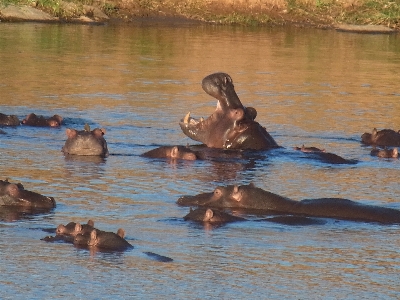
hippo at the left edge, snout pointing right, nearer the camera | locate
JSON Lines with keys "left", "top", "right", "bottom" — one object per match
{"left": 0, "top": 180, "right": 56, "bottom": 209}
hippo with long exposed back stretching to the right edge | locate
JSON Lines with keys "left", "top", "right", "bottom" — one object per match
{"left": 177, "top": 184, "right": 400, "bottom": 224}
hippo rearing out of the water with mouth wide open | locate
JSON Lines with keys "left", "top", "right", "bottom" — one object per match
{"left": 179, "top": 73, "right": 279, "bottom": 150}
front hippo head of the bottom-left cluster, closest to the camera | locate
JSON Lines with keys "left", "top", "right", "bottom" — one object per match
{"left": 74, "top": 228, "right": 133, "bottom": 251}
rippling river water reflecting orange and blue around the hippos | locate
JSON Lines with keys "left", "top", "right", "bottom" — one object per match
{"left": 0, "top": 23, "right": 400, "bottom": 299}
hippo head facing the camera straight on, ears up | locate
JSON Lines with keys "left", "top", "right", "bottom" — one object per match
{"left": 61, "top": 124, "right": 109, "bottom": 157}
